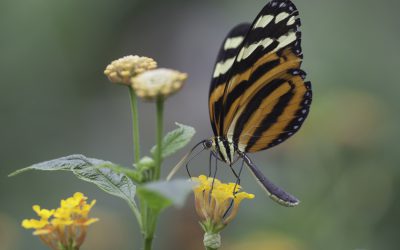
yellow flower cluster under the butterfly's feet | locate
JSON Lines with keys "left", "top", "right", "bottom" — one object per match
{"left": 192, "top": 175, "right": 254, "bottom": 233}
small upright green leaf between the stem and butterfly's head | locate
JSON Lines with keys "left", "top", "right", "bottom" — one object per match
{"left": 151, "top": 122, "right": 196, "bottom": 158}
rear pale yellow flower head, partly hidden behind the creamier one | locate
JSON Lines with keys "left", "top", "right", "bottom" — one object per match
{"left": 104, "top": 55, "right": 157, "bottom": 85}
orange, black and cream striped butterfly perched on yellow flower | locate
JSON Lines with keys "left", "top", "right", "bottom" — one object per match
{"left": 169, "top": 0, "right": 312, "bottom": 206}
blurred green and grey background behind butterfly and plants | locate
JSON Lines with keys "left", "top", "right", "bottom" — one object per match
{"left": 0, "top": 0, "right": 400, "bottom": 250}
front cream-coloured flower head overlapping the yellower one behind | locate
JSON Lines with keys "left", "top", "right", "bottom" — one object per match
{"left": 131, "top": 68, "right": 187, "bottom": 100}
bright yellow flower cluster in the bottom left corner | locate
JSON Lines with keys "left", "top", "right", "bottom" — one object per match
{"left": 22, "top": 192, "right": 98, "bottom": 249}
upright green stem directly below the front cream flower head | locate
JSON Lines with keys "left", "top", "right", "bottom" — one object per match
{"left": 154, "top": 97, "right": 164, "bottom": 180}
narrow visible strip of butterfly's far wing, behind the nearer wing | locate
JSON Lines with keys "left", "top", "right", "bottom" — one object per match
{"left": 208, "top": 24, "right": 250, "bottom": 136}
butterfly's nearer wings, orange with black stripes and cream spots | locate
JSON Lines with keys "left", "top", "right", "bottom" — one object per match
{"left": 210, "top": 0, "right": 311, "bottom": 152}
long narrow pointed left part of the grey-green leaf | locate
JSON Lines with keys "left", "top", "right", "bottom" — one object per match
{"left": 8, "top": 154, "right": 109, "bottom": 177}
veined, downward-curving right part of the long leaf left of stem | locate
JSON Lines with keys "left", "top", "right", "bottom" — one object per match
{"left": 72, "top": 166, "right": 136, "bottom": 208}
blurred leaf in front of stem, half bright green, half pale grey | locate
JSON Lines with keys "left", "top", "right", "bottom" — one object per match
{"left": 137, "top": 179, "right": 194, "bottom": 211}
